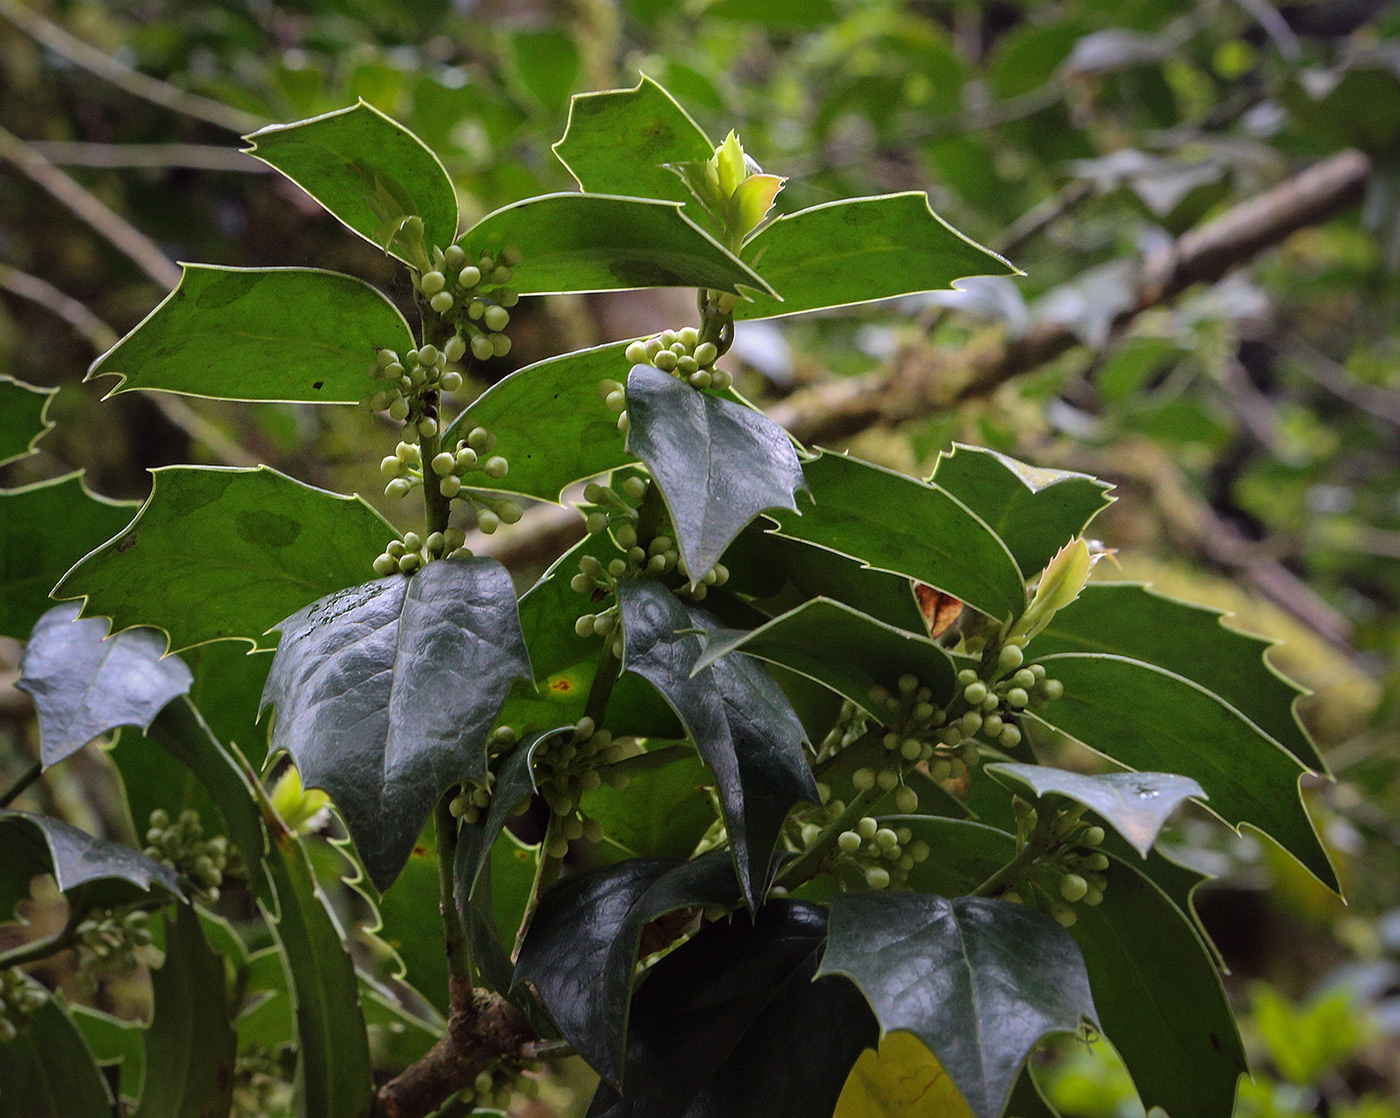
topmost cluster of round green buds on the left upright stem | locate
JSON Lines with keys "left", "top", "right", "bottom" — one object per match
{"left": 413, "top": 245, "right": 524, "bottom": 361}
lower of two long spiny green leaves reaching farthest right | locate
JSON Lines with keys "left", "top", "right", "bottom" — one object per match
{"left": 1029, "top": 652, "right": 1338, "bottom": 891}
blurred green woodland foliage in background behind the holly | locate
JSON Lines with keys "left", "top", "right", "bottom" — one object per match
{"left": 0, "top": 0, "right": 1400, "bottom": 1118}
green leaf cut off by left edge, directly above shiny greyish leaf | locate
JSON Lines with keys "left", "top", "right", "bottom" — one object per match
{"left": 0, "top": 473, "right": 136, "bottom": 641}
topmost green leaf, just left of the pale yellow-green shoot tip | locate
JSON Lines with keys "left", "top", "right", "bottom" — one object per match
{"left": 553, "top": 74, "right": 714, "bottom": 201}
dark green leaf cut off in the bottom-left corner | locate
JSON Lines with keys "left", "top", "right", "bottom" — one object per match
{"left": 0, "top": 998, "right": 112, "bottom": 1118}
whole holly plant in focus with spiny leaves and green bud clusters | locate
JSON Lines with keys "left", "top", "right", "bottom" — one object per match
{"left": 0, "top": 80, "right": 1337, "bottom": 1118}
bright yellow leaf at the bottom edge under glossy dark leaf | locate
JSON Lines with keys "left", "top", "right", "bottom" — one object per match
{"left": 832, "top": 1031, "right": 973, "bottom": 1118}
